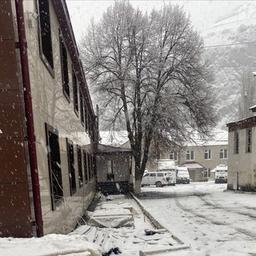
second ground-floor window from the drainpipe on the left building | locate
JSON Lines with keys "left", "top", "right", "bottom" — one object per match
{"left": 67, "top": 139, "right": 76, "bottom": 196}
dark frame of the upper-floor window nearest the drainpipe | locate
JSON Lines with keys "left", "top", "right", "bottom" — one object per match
{"left": 36, "top": 0, "right": 55, "bottom": 78}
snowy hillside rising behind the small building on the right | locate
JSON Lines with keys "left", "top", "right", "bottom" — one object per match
{"left": 203, "top": 2, "right": 256, "bottom": 128}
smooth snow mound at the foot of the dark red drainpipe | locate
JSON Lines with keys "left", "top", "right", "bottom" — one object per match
{"left": 0, "top": 234, "right": 101, "bottom": 256}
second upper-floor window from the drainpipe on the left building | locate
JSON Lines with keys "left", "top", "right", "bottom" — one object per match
{"left": 60, "top": 35, "right": 70, "bottom": 101}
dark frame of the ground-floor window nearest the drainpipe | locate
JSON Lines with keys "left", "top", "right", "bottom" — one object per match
{"left": 45, "top": 123, "right": 64, "bottom": 211}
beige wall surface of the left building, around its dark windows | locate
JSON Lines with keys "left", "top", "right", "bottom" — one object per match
{"left": 24, "top": 1, "right": 95, "bottom": 234}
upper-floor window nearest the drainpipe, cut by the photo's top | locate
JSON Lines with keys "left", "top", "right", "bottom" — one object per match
{"left": 38, "top": 0, "right": 53, "bottom": 70}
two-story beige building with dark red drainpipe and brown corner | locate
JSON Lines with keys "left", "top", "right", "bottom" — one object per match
{"left": 0, "top": 0, "right": 97, "bottom": 237}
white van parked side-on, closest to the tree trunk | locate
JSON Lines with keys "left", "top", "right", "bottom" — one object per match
{"left": 141, "top": 169, "right": 176, "bottom": 187}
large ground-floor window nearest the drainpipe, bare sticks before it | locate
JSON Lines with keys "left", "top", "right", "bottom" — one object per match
{"left": 45, "top": 124, "right": 63, "bottom": 210}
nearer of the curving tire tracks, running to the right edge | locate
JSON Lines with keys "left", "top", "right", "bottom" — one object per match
{"left": 175, "top": 196, "right": 256, "bottom": 239}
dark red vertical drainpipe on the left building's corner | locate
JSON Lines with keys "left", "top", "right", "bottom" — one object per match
{"left": 15, "top": 0, "right": 43, "bottom": 237}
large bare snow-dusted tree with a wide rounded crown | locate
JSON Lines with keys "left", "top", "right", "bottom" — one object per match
{"left": 81, "top": 1, "right": 214, "bottom": 192}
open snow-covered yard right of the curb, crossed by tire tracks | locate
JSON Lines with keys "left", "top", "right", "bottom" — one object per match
{"left": 140, "top": 182, "right": 256, "bottom": 256}
